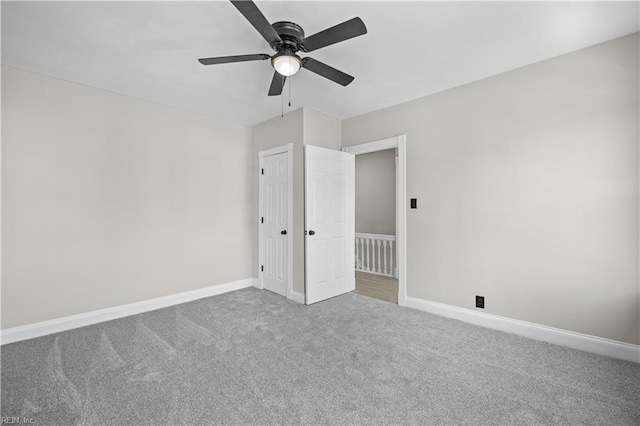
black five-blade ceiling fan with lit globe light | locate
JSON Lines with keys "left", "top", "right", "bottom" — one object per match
{"left": 198, "top": 0, "right": 367, "bottom": 96}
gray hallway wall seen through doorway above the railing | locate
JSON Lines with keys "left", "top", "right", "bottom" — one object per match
{"left": 356, "top": 149, "right": 396, "bottom": 235}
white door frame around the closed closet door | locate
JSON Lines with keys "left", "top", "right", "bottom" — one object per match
{"left": 258, "top": 143, "right": 293, "bottom": 299}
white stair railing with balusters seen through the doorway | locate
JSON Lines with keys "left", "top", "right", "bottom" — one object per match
{"left": 355, "top": 233, "right": 397, "bottom": 277}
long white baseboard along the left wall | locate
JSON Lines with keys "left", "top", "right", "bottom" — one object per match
{"left": 0, "top": 278, "right": 255, "bottom": 345}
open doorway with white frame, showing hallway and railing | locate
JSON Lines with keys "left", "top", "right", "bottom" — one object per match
{"left": 342, "top": 135, "right": 406, "bottom": 306}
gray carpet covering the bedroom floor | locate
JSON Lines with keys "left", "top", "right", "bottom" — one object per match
{"left": 1, "top": 289, "right": 640, "bottom": 425}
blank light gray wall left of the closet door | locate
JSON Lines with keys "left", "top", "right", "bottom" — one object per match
{"left": 2, "top": 67, "right": 254, "bottom": 328}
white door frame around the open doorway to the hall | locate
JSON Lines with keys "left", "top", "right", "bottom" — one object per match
{"left": 342, "top": 135, "right": 407, "bottom": 306}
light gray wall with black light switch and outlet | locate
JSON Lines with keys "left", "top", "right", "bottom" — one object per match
{"left": 342, "top": 34, "right": 640, "bottom": 344}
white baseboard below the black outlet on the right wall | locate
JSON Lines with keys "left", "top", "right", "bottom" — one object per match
{"left": 405, "top": 297, "right": 640, "bottom": 363}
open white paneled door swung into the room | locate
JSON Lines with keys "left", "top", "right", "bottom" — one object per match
{"left": 304, "top": 145, "right": 356, "bottom": 305}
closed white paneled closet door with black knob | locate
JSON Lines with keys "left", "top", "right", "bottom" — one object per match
{"left": 259, "top": 146, "right": 292, "bottom": 298}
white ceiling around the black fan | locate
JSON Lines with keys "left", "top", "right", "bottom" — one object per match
{"left": 2, "top": 1, "right": 639, "bottom": 125}
